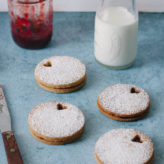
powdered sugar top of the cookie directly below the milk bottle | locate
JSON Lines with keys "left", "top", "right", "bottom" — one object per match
{"left": 98, "top": 84, "right": 150, "bottom": 115}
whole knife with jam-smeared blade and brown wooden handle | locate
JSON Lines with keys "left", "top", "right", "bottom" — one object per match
{"left": 0, "top": 85, "right": 23, "bottom": 164}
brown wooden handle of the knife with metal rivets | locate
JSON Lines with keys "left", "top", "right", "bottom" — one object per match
{"left": 2, "top": 131, "right": 23, "bottom": 164}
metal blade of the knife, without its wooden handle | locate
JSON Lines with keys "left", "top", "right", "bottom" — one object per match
{"left": 0, "top": 85, "right": 11, "bottom": 132}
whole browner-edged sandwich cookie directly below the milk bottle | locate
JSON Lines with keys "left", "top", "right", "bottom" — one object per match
{"left": 97, "top": 84, "right": 150, "bottom": 121}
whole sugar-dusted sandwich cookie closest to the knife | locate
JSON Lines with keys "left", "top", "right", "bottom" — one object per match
{"left": 28, "top": 101, "right": 85, "bottom": 145}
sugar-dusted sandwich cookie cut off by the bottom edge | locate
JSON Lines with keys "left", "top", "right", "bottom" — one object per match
{"left": 95, "top": 129, "right": 154, "bottom": 164}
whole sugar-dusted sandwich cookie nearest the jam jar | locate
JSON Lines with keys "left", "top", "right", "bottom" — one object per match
{"left": 34, "top": 56, "right": 86, "bottom": 93}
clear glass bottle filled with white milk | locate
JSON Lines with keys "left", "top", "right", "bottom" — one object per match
{"left": 94, "top": 0, "right": 138, "bottom": 69}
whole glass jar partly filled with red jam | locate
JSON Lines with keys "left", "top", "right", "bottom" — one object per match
{"left": 8, "top": 0, "right": 53, "bottom": 49}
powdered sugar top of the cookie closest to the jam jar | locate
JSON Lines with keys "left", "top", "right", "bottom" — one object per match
{"left": 35, "top": 56, "right": 86, "bottom": 85}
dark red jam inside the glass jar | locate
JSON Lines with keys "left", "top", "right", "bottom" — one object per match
{"left": 11, "top": 14, "right": 52, "bottom": 49}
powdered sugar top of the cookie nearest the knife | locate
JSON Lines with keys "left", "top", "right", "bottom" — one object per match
{"left": 28, "top": 102, "right": 85, "bottom": 137}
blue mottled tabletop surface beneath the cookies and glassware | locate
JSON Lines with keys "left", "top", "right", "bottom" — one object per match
{"left": 0, "top": 13, "right": 164, "bottom": 164}
